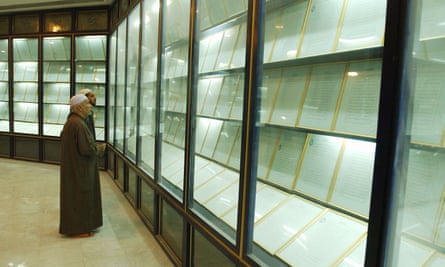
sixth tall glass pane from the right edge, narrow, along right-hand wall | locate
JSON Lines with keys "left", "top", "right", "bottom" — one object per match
{"left": 125, "top": 5, "right": 141, "bottom": 161}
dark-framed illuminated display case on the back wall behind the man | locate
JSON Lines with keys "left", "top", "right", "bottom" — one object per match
{"left": 0, "top": 7, "right": 108, "bottom": 163}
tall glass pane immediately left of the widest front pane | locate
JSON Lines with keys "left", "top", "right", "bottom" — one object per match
{"left": 189, "top": 0, "right": 246, "bottom": 243}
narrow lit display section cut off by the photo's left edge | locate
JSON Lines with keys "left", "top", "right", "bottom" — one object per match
{"left": 0, "top": 39, "right": 10, "bottom": 132}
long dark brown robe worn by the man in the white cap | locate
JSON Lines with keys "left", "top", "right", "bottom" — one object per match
{"left": 59, "top": 113, "right": 103, "bottom": 235}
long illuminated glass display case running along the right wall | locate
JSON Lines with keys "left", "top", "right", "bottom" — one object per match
{"left": 103, "top": 0, "right": 445, "bottom": 266}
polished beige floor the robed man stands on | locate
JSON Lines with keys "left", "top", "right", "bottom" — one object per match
{"left": 0, "top": 158, "right": 173, "bottom": 267}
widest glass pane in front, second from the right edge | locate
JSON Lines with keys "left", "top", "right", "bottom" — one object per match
{"left": 250, "top": 0, "right": 386, "bottom": 266}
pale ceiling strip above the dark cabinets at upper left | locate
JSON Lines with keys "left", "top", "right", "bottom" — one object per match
{"left": 0, "top": 0, "right": 114, "bottom": 14}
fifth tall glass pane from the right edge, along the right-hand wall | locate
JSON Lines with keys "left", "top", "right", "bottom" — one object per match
{"left": 139, "top": 0, "right": 159, "bottom": 178}
